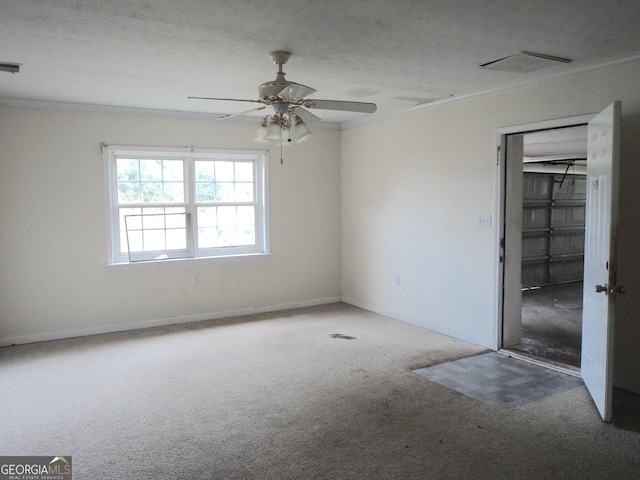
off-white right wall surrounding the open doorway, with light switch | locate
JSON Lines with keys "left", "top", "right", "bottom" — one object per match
{"left": 341, "top": 60, "right": 640, "bottom": 392}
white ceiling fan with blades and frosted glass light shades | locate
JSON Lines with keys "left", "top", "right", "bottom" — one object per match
{"left": 188, "top": 50, "right": 377, "bottom": 145}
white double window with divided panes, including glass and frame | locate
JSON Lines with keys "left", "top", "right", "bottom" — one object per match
{"left": 105, "top": 146, "right": 267, "bottom": 264}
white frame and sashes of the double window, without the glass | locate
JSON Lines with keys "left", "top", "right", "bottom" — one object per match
{"left": 103, "top": 145, "right": 269, "bottom": 265}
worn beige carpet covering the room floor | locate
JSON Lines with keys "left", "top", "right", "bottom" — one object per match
{"left": 0, "top": 304, "right": 640, "bottom": 480}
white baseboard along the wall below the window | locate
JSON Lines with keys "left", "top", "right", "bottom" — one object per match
{"left": 0, "top": 297, "right": 341, "bottom": 347}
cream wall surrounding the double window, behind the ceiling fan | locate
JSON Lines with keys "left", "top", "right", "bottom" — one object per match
{"left": 0, "top": 107, "right": 340, "bottom": 345}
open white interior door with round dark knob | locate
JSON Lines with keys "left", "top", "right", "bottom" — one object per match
{"left": 581, "top": 102, "right": 621, "bottom": 421}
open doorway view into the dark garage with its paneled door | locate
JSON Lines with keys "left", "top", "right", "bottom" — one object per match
{"left": 503, "top": 125, "right": 587, "bottom": 375}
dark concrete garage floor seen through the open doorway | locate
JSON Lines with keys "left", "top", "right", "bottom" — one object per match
{"left": 511, "top": 282, "right": 582, "bottom": 368}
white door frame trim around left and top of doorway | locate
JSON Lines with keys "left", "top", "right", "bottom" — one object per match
{"left": 494, "top": 113, "right": 596, "bottom": 350}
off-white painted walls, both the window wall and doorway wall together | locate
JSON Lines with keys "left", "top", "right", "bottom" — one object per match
{"left": 0, "top": 60, "right": 640, "bottom": 392}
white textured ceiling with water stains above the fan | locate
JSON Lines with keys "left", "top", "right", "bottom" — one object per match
{"left": 0, "top": 0, "right": 640, "bottom": 123}
